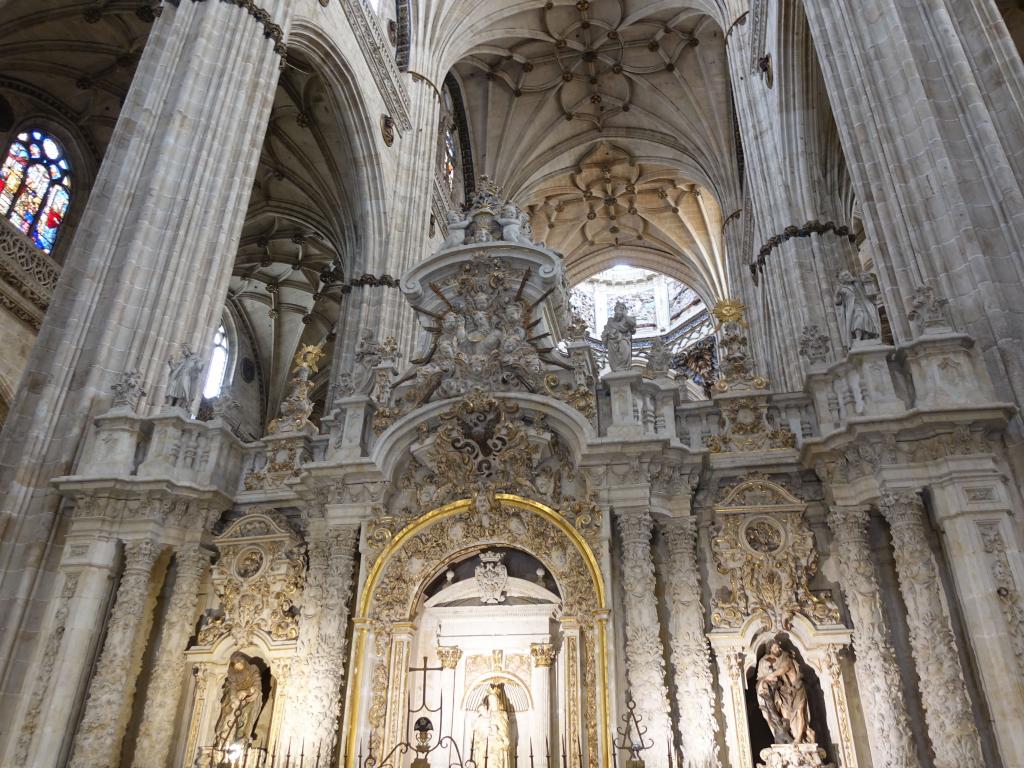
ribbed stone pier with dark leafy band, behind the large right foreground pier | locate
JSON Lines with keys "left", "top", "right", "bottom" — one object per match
{"left": 726, "top": 2, "right": 856, "bottom": 389}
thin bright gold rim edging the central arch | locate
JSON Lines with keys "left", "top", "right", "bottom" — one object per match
{"left": 345, "top": 494, "right": 613, "bottom": 768}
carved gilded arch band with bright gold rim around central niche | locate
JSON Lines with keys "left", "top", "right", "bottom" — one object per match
{"left": 345, "top": 494, "right": 611, "bottom": 768}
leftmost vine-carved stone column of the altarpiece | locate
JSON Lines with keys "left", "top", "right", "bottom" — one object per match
{"left": 69, "top": 539, "right": 161, "bottom": 768}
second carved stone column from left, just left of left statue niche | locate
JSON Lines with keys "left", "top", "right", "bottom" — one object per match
{"left": 132, "top": 543, "right": 211, "bottom": 768}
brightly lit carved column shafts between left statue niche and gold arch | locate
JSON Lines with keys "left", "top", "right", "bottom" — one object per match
{"left": 282, "top": 525, "right": 358, "bottom": 754}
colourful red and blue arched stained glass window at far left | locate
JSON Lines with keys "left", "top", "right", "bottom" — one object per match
{"left": 0, "top": 131, "right": 71, "bottom": 253}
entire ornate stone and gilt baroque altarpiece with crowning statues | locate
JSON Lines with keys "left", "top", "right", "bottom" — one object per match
{"left": 4, "top": 179, "right": 1024, "bottom": 768}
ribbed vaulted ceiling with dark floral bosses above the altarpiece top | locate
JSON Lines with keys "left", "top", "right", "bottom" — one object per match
{"left": 454, "top": 0, "right": 739, "bottom": 300}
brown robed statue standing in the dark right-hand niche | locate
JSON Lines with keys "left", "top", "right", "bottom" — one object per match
{"left": 757, "top": 643, "right": 814, "bottom": 744}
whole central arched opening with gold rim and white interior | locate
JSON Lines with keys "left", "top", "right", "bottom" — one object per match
{"left": 345, "top": 494, "right": 611, "bottom": 768}
